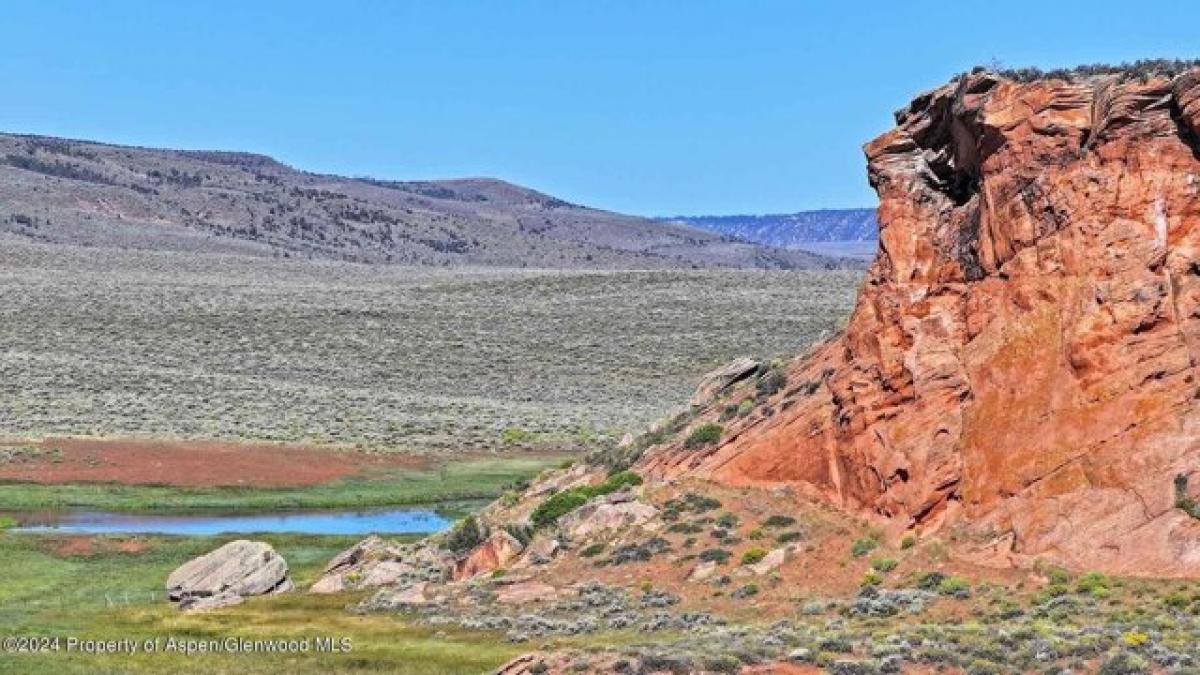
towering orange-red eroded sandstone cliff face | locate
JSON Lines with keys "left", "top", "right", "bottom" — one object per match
{"left": 642, "top": 71, "right": 1200, "bottom": 577}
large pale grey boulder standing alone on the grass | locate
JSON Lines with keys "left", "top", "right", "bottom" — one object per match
{"left": 167, "top": 539, "right": 293, "bottom": 611}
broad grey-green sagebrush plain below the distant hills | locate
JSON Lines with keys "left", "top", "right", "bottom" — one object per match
{"left": 0, "top": 237, "right": 860, "bottom": 452}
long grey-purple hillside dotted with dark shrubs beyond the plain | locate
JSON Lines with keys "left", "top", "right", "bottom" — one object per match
{"left": 0, "top": 135, "right": 857, "bottom": 269}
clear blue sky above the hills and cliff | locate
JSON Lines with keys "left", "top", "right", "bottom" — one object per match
{"left": 0, "top": 0, "right": 1200, "bottom": 215}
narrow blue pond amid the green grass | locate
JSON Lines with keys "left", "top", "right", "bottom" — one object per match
{"left": 11, "top": 509, "right": 450, "bottom": 537}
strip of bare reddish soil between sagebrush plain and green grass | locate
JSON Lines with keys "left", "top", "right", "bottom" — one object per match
{"left": 0, "top": 438, "right": 430, "bottom": 488}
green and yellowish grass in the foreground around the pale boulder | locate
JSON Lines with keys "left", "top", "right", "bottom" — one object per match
{"left": 0, "top": 533, "right": 521, "bottom": 675}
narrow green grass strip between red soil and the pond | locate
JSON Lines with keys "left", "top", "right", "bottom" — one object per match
{"left": 0, "top": 456, "right": 562, "bottom": 511}
